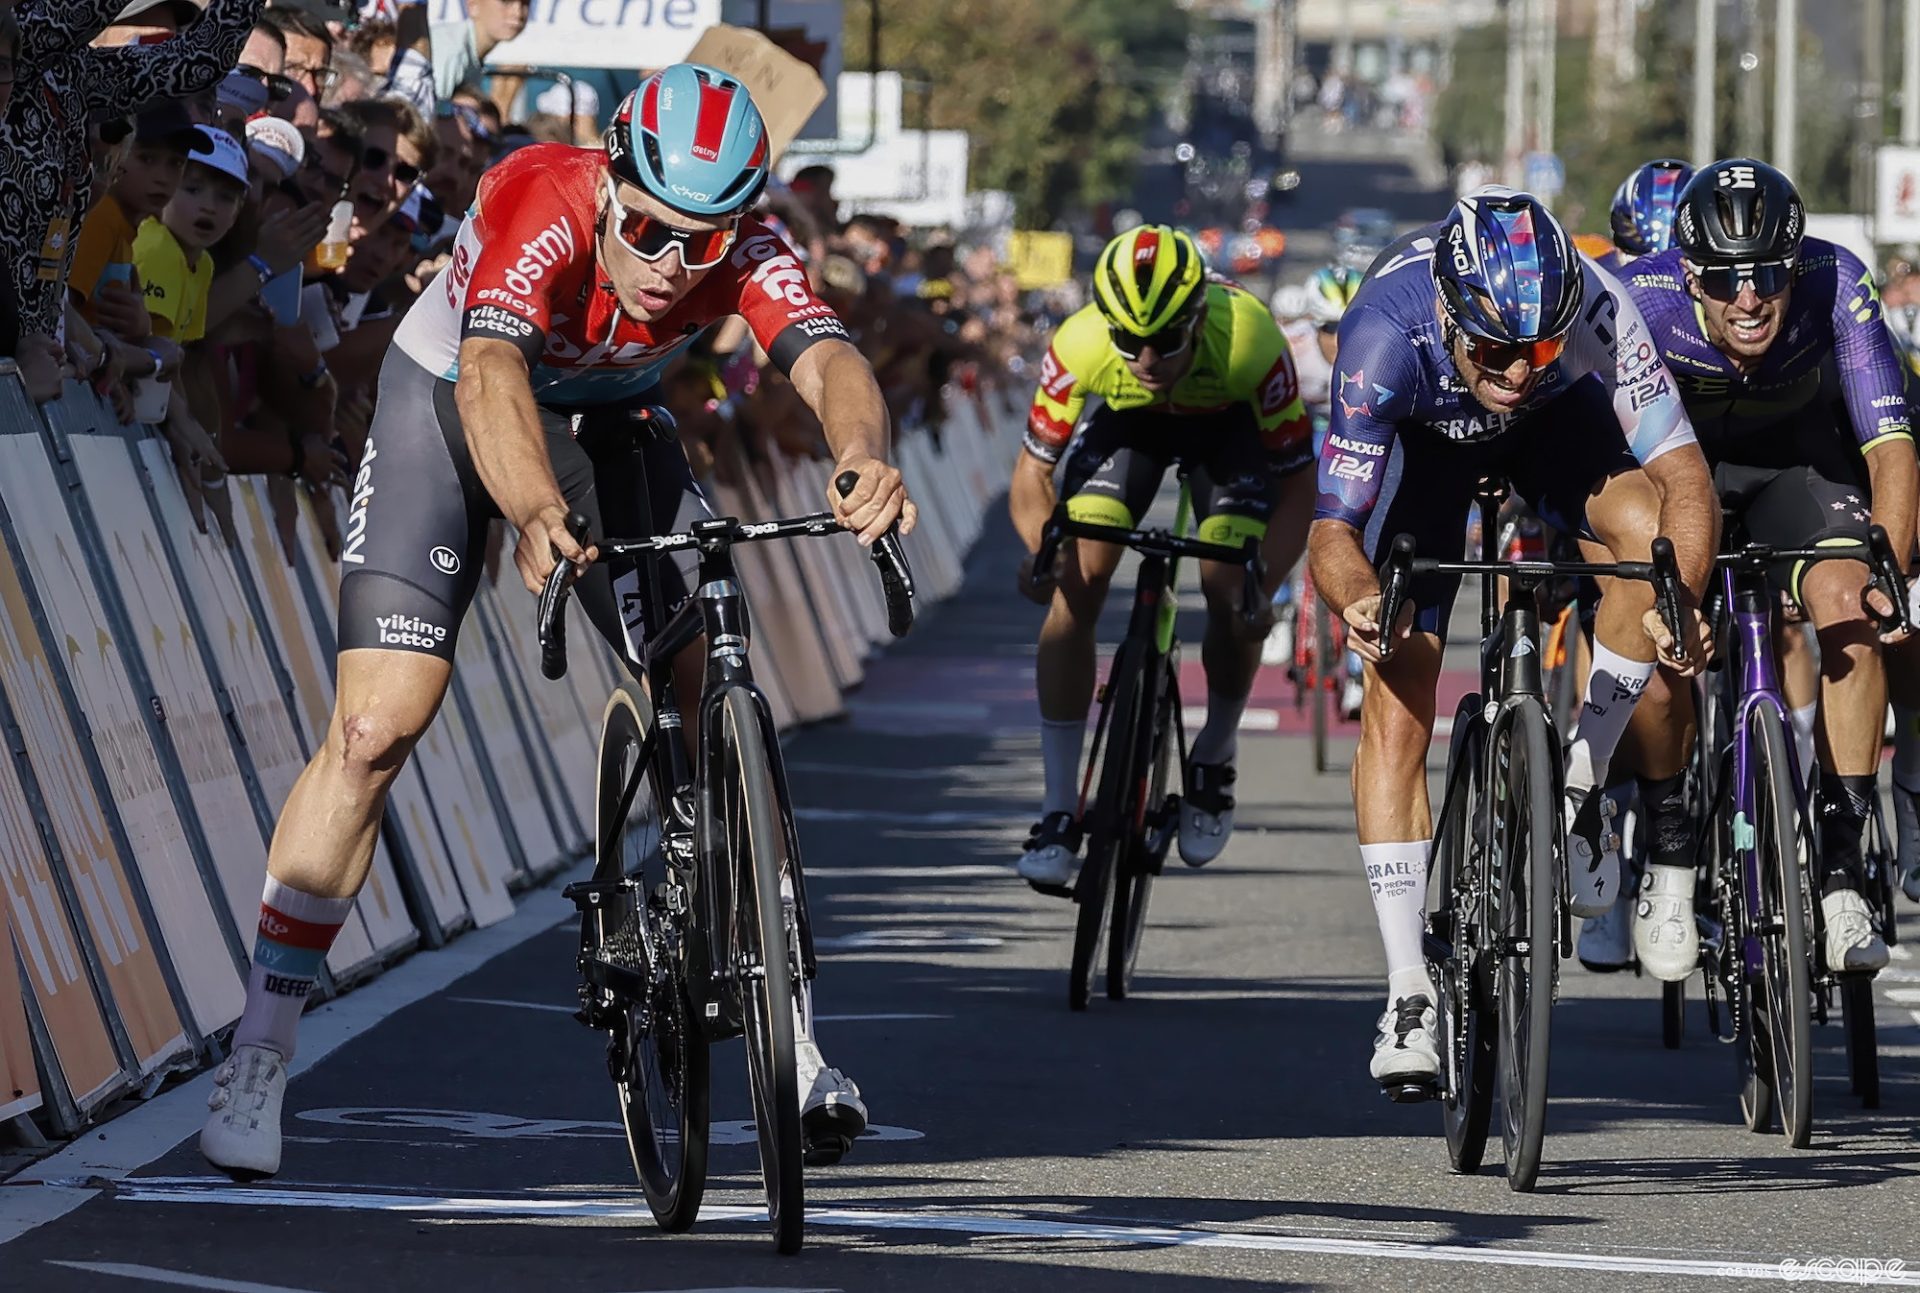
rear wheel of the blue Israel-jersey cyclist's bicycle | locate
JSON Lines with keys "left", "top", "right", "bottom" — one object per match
{"left": 1427, "top": 695, "right": 1500, "bottom": 1174}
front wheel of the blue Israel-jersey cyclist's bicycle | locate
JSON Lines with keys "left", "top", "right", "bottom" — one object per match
{"left": 1492, "top": 697, "right": 1563, "bottom": 1193}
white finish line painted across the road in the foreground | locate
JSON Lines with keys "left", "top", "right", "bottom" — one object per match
{"left": 93, "top": 1176, "right": 1920, "bottom": 1287}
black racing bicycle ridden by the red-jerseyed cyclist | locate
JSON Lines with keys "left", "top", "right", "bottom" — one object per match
{"left": 540, "top": 453, "right": 914, "bottom": 1253}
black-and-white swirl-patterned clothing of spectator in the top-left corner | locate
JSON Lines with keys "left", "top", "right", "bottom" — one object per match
{"left": 0, "top": 0, "right": 261, "bottom": 334}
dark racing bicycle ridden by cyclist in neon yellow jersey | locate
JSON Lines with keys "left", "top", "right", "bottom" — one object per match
{"left": 1029, "top": 469, "right": 1265, "bottom": 1011}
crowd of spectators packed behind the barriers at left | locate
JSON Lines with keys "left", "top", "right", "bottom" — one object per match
{"left": 0, "top": 0, "right": 1044, "bottom": 564}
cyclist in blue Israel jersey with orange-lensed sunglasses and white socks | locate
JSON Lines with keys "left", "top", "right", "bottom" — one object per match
{"left": 1309, "top": 188, "right": 1718, "bottom": 1086}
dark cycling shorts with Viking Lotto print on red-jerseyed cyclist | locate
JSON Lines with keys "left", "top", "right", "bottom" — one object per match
{"left": 340, "top": 350, "right": 710, "bottom": 661}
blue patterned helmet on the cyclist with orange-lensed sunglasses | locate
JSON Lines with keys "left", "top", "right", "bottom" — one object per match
{"left": 1434, "top": 186, "right": 1582, "bottom": 346}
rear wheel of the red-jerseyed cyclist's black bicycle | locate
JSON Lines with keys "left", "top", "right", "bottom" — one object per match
{"left": 582, "top": 682, "right": 710, "bottom": 1232}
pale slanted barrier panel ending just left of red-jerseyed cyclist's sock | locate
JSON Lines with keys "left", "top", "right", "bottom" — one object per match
{"left": 0, "top": 432, "right": 246, "bottom": 1034}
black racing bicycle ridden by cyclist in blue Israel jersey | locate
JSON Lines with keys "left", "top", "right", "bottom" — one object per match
{"left": 1379, "top": 482, "right": 1680, "bottom": 1191}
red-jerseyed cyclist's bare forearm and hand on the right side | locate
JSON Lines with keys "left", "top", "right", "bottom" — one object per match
{"left": 787, "top": 338, "right": 918, "bottom": 544}
